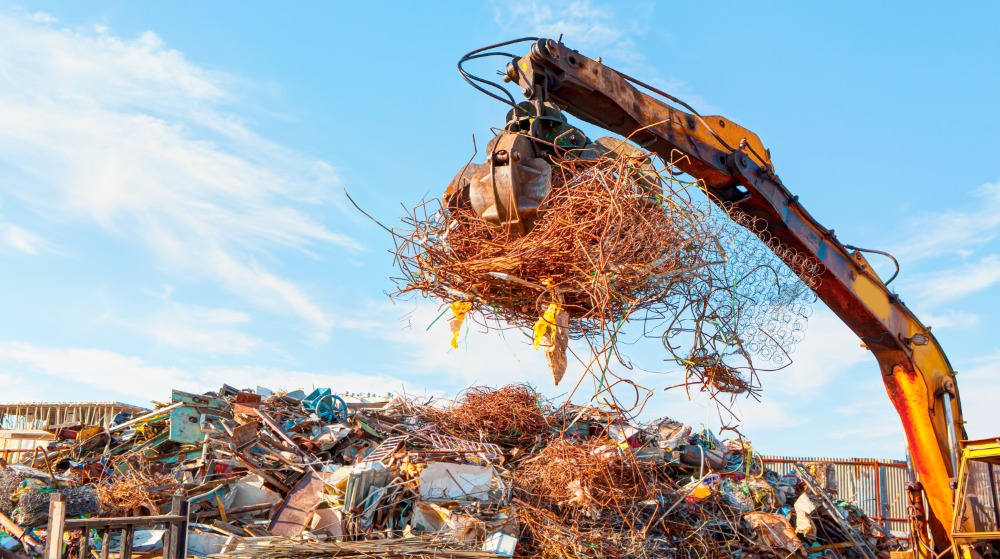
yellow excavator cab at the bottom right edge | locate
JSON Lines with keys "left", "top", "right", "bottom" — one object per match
{"left": 951, "top": 439, "right": 1000, "bottom": 558}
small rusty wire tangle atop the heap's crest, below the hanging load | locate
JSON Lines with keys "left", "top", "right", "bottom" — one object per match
{"left": 418, "top": 384, "right": 549, "bottom": 447}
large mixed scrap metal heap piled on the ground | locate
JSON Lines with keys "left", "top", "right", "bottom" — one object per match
{"left": 0, "top": 385, "right": 898, "bottom": 559}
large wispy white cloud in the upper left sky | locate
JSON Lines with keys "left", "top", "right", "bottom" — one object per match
{"left": 0, "top": 14, "right": 359, "bottom": 336}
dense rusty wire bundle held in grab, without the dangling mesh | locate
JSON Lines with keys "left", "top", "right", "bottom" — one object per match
{"left": 396, "top": 151, "right": 719, "bottom": 335}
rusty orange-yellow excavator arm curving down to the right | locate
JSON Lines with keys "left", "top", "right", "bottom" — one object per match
{"left": 496, "top": 39, "right": 964, "bottom": 550}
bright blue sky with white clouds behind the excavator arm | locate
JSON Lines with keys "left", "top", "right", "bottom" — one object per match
{"left": 0, "top": 0, "right": 1000, "bottom": 457}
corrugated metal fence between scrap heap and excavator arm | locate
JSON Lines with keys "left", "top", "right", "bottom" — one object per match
{"left": 763, "top": 456, "right": 910, "bottom": 536}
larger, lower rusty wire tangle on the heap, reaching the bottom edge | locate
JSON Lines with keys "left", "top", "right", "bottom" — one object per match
{"left": 514, "top": 439, "right": 749, "bottom": 559}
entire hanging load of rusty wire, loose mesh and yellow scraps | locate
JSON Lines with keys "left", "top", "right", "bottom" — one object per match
{"left": 392, "top": 140, "right": 820, "bottom": 397}
